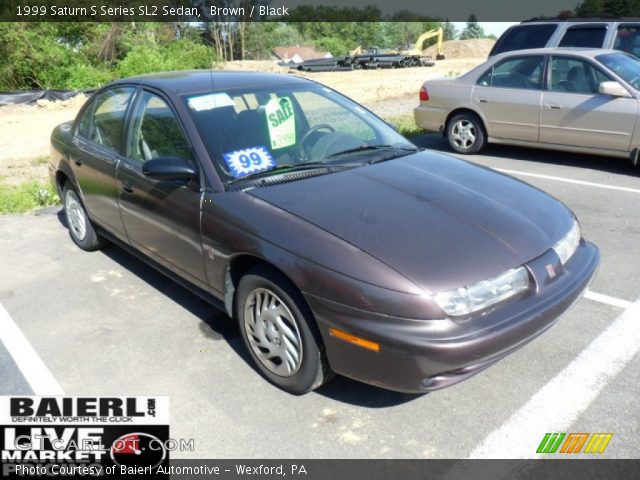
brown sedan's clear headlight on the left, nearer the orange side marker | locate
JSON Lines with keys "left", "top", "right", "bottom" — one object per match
{"left": 434, "top": 267, "right": 529, "bottom": 317}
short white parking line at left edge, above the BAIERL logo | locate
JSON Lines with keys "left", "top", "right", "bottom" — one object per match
{"left": 0, "top": 304, "right": 64, "bottom": 395}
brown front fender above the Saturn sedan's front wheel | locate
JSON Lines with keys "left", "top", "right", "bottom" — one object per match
{"left": 202, "top": 192, "right": 441, "bottom": 318}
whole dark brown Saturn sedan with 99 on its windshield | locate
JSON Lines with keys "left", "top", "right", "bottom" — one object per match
{"left": 50, "top": 71, "right": 599, "bottom": 394}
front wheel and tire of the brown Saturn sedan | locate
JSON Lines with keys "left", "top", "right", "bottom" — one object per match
{"left": 235, "top": 266, "right": 333, "bottom": 395}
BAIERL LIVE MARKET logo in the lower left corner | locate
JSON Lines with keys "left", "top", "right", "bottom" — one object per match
{"left": 0, "top": 396, "right": 169, "bottom": 477}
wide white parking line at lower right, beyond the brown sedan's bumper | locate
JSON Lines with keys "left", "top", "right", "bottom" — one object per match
{"left": 469, "top": 300, "right": 640, "bottom": 458}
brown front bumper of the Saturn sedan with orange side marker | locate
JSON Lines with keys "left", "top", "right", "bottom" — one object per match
{"left": 305, "top": 241, "right": 600, "bottom": 393}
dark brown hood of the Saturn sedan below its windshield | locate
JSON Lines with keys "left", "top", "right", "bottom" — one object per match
{"left": 248, "top": 152, "right": 573, "bottom": 292}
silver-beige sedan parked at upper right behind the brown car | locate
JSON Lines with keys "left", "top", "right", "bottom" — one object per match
{"left": 414, "top": 48, "right": 640, "bottom": 164}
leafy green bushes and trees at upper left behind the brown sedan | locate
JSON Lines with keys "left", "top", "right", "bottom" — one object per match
{"left": 0, "top": 22, "right": 213, "bottom": 90}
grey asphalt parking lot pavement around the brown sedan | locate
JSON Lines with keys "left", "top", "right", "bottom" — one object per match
{"left": 0, "top": 135, "right": 640, "bottom": 458}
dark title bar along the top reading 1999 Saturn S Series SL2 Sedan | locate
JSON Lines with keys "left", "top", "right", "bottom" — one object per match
{"left": 0, "top": 0, "right": 624, "bottom": 22}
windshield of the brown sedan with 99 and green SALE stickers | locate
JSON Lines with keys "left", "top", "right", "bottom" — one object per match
{"left": 185, "top": 84, "right": 416, "bottom": 183}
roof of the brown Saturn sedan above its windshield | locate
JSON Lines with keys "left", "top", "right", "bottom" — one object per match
{"left": 112, "top": 70, "right": 315, "bottom": 95}
